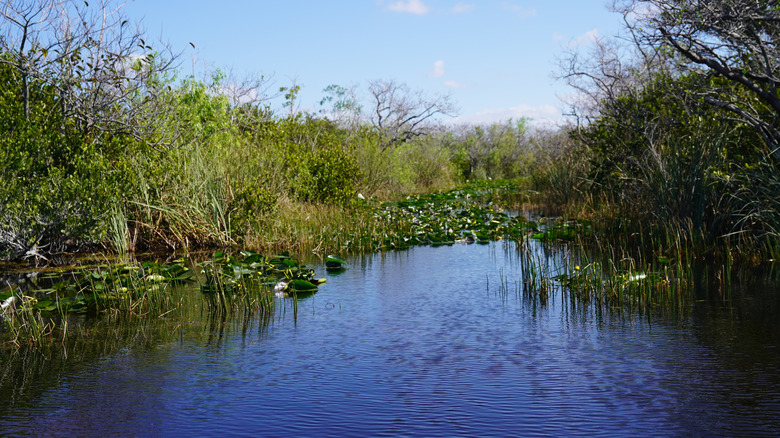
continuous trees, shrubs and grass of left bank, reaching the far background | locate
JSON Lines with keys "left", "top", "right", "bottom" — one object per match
{"left": 0, "top": 2, "right": 528, "bottom": 262}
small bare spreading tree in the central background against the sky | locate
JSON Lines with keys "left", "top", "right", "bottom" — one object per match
{"left": 368, "top": 80, "right": 457, "bottom": 150}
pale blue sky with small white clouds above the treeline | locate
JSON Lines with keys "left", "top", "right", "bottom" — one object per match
{"left": 126, "top": 0, "right": 621, "bottom": 123}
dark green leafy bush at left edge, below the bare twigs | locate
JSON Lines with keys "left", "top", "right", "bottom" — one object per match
{"left": 0, "top": 57, "right": 135, "bottom": 258}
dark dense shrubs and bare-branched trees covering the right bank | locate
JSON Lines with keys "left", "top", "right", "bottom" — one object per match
{"left": 536, "top": 0, "right": 780, "bottom": 259}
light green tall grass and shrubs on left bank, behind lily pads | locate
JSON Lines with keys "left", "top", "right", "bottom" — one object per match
{"left": 118, "top": 113, "right": 455, "bottom": 253}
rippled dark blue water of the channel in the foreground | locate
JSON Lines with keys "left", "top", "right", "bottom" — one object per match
{"left": 0, "top": 243, "right": 780, "bottom": 437}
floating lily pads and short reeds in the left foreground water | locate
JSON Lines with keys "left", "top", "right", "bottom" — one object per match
{"left": 0, "top": 251, "right": 330, "bottom": 346}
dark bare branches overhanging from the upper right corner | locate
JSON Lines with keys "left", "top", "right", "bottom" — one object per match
{"left": 616, "top": 0, "right": 780, "bottom": 161}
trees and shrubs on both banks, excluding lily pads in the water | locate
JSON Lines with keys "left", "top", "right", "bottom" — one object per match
{"left": 0, "top": 1, "right": 780, "bottom": 262}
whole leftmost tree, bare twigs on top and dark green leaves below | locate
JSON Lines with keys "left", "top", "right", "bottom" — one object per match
{"left": 0, "top": 0, "right": 187, "bottom": 260}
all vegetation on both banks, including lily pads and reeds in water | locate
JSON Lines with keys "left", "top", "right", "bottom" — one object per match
{"left": 0, "top": 1, "right": 780, "bottom": 344}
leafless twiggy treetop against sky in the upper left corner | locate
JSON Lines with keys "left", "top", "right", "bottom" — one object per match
{"left": 0, "top": 0, "right": 176, "bottom": 146}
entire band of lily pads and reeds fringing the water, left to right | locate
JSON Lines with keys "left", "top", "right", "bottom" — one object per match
{"left": 0, "top": 181, "right": 760, "bottom": 347}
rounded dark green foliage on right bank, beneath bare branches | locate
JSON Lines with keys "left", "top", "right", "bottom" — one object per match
{"left": 564, "top": 67, "right": 776, "bottom": 238}
